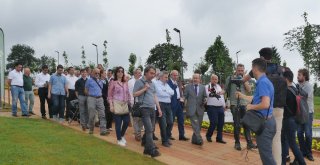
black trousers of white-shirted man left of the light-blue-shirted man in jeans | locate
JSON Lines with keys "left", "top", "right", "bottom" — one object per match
{"left": 38, "top": 88, "right": 53, "bottom": 118}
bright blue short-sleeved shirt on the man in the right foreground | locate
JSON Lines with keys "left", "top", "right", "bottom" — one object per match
{"left": 252, "top": 75, "right": 274, "bottom": 117}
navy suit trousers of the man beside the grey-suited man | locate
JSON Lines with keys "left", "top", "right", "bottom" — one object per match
{"left": 168, "top": 100, "right": 184, "bottom": 138}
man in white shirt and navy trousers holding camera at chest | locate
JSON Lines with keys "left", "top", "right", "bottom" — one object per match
{"left": 206, "top": 74, "right": 226, "bottom": 144}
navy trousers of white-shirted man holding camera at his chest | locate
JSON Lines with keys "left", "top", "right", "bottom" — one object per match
{"left": 206, "top": 105, "right": 224, "bottom": 140}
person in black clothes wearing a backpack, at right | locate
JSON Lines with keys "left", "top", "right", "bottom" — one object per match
{"left": 281, "top": 71, "right": 306, "bottom": 165}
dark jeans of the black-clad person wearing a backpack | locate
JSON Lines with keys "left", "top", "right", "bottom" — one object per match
{"left": 281, "top": 117, "right": 306, "bottom": 165}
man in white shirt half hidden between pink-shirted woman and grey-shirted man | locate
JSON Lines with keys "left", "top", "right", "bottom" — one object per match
{"left": 128, "top": 68, "right": 143, "bottom": 141}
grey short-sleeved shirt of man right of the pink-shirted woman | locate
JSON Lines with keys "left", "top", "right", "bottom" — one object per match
{"left": 133, "top": 77, "right": 156, "bottom": 108}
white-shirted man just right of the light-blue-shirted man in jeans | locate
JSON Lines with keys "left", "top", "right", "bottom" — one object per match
{"left": 66, "top": 66, "right": 79, "bottom": 121}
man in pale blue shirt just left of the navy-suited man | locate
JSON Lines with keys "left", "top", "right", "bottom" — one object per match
{"left": 155, "top": 71, "right": 174, "bottom": 147}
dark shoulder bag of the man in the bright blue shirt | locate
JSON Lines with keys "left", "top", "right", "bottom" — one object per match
{"left": 241, "top": 102, "right": 271, "bottom": 135}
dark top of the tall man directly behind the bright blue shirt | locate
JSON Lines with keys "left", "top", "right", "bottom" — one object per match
{"left": 266, "top": 63, "right": 287, "bottom": 107}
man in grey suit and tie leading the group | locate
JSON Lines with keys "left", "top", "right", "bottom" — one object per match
{"left": 184, "top": 74, "right": 207, "bottom": 145}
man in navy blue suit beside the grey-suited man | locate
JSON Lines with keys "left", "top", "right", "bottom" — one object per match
{"left": 168, "top": 70, "right": 189, "bottom": 141}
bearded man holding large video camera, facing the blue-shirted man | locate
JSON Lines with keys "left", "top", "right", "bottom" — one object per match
{"left": 225, "top": 64, "right": 256, "bottom": 151}
